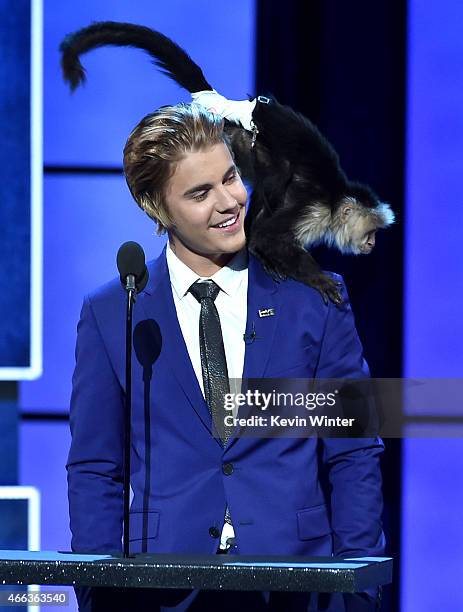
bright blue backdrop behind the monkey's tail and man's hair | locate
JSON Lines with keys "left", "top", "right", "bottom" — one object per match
{"left": 19, "top": 5, "right": 255, "bottom": 612}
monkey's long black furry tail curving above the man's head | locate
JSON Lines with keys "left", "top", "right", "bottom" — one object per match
{"left": 60, "top": 21, "right": 213, "bottom": 93}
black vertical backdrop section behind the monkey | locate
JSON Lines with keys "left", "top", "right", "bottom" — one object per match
{"left": 256, "top": 0, "right": 407, "bottom": 611}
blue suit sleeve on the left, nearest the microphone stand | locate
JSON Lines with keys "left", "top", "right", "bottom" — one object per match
{"left": 66, "top": 298, "right": 124, "bottom": 553}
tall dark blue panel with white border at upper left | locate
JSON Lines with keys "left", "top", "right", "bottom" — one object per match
{"left": 0, "top": 0, "right": 41, "bottom": 380}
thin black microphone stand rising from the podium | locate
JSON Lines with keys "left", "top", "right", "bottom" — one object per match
{"left": 123, "top": 274, "right": 137, "bottom": 558}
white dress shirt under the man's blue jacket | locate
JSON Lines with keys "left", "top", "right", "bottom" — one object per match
{"left": 166, "top": 243, "right": 248, "bottom": 547}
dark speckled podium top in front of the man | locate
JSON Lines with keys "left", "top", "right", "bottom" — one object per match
{"left": 0, "top": 550, "right": 392, "bottom": 593}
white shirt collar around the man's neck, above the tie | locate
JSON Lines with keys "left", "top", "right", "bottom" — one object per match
{"left": 166, "top": 242, "right": 248, "bottom": 300}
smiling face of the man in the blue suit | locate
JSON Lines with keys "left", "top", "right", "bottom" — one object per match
{"left": 165, "top": 143, "right": 247, "bottom": 271}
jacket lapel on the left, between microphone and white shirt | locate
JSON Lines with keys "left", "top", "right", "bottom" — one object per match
{"left": 139, "top": 248, "right": 220, "bottom": 444}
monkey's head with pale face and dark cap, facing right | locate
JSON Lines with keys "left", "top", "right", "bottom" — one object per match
{"left": 329, "top": 183, "right": 394, "bottom": 255}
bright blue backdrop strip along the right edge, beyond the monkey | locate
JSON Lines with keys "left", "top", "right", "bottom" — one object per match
{"left": 401, "top": 0, "right": 463, "bottom": 612}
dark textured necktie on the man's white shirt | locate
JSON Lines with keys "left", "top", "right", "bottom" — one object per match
{"left": 189, "top": 280, "right": 233, "bottom": 446}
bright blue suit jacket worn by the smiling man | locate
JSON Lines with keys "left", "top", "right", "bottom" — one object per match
{"left": 67, "top": 246, "right": 384, "bottom": 555}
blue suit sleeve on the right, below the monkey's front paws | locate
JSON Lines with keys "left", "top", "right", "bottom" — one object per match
{"left": 316, "top": 277, "right": 385, "bottom": 556}
